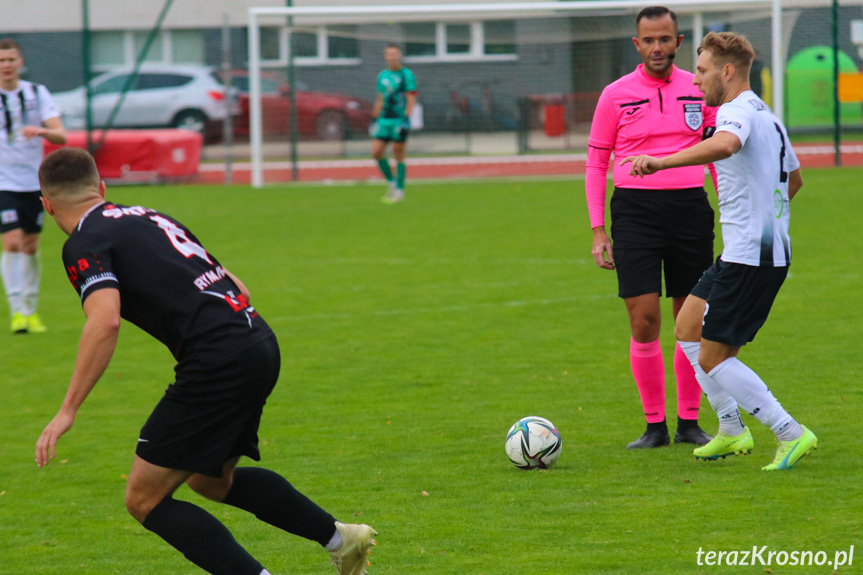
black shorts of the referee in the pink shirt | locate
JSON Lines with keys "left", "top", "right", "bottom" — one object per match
{"left": 611, "top": 188, "right": 714, "bottom": 298}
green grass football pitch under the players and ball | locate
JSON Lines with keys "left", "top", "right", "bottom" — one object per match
{"left": 0, "top": 169, "right": 863, "bottom": 575}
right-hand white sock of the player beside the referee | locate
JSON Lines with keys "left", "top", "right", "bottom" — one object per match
{"left": 709, "top": 357, "right": 803, "bottom": 441}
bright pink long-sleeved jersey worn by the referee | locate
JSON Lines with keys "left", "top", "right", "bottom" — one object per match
{"left": 585, "top": 64, "right": 716, "bottom": 228}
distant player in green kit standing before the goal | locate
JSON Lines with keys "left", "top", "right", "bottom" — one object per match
{"left": 370, "top": 44, "right": 417, "bottom": 204}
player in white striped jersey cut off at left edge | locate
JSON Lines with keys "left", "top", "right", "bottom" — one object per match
{"left": 0, "top": 38, "right": 66, "bottom": 333}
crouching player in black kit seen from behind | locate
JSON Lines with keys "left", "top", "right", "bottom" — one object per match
{"left": 36, "top": 148, "right": 375, "bottom": 575}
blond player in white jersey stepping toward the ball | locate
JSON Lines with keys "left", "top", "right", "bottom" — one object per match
{"left": 623, "top": 32, "right": 818, "bottom": 471}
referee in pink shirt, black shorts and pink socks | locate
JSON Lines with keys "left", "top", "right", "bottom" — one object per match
{"left": 585, "top": 6, "right": 716, "bottom": 449}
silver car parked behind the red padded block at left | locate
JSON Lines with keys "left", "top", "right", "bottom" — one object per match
{"left": 53, "top": 65, "right": 239, "bottom": 139}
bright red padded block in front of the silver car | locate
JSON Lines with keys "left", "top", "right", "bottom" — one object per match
{"left": 45, "top": 130, "right": 203, "bottom": 181}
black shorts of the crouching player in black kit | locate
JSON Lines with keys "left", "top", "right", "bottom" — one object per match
{"left": 135, "top": 336, "right": 281, "bottom": 477}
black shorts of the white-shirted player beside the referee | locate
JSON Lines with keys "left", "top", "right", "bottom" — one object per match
{"left": 692, "top": 258, "right": 788, "bottom": 347}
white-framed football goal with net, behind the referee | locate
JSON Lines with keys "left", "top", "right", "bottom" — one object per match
{"left": 248, "top": 0, "right": 788, "bottom": 186}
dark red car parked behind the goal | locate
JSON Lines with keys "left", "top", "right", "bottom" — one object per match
{"left": 224, "top": 70, "right": 372, "bottom": 140}
